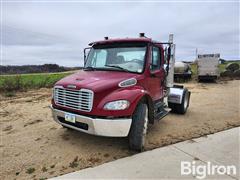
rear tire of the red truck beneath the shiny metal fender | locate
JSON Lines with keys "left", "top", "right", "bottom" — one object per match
{"left": 168, "top": 89, "right": 190, "bottom": 114}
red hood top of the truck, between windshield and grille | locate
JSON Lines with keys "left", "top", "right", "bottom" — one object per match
{"left": 55, "top": 70, "right": 138, "bottom": 92}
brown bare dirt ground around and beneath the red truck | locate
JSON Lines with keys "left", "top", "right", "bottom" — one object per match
{"left": 0, "top": 80, "right": 240, "bottom": 179}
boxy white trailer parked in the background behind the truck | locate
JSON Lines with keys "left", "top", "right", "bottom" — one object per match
{"left": 197, "top": 54, "right": 220, "bottom": 81}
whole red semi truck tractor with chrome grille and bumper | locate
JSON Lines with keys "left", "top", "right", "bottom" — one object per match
{"left": 51, "top": 33, "right": 190, "bottom": 151}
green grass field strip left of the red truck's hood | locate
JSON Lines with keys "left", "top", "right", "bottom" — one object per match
{"left": 0, "top": 72, "right": 73, "bottom": 93}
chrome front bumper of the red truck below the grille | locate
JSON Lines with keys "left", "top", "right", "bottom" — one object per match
{"left": 51, "top": 106, "right": 132, "bottom": 137}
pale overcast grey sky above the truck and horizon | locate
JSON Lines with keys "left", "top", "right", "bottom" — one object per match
{"left": 1, "top": 0, "right": 240, "bottom": 66}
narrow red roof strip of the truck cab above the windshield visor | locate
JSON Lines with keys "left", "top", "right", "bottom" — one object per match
{"left": 89, "top": 38, "right": 153, "bottom": 46}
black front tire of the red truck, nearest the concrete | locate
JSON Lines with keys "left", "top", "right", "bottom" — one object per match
{"left": 128, "top": 103, "right": 148, "bottom": 151}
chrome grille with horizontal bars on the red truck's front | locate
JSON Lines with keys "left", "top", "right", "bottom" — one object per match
{"left": 54, "top": 87, "right": 93, "bottom": 112}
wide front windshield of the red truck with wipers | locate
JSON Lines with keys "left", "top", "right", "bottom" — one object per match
{"left": 85, "top": 45, "right": 146, "bottom": 73}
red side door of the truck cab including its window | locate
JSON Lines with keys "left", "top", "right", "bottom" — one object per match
{"left": 148, "top": 45, "right": 165, "bottom": 101}
